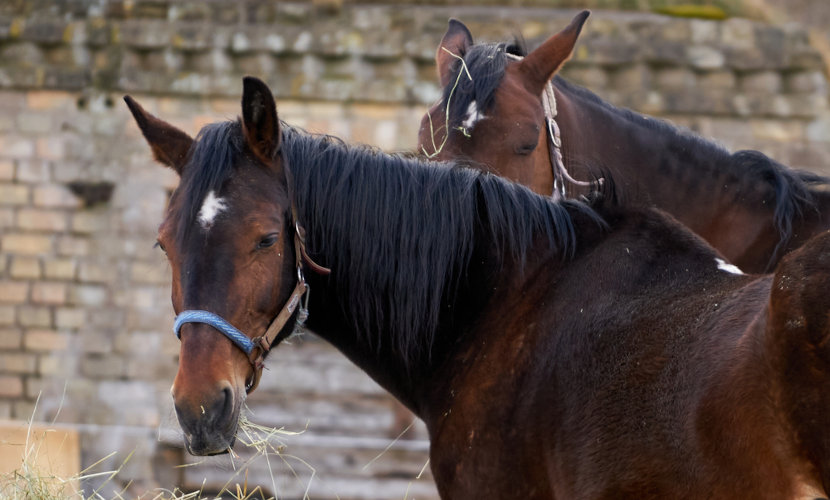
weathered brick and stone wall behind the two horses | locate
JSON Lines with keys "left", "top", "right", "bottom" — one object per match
{"left": 0, "top": 0, "right": 830, "bottom": 498}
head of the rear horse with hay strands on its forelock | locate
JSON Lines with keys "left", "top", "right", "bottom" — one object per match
{"left": 418, "top": 11, "right": 589, "bottom": 195}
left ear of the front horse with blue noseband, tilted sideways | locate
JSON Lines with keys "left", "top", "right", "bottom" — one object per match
{"left": 124, "top": 95, "right": 193, "bottom": 175}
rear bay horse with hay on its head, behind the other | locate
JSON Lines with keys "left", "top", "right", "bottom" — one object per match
{"left": 419, "top": 11, "right": 830, "bottom": 272}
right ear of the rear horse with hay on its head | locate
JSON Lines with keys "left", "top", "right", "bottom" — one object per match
{"left": 520, "top": 10, "right": 591, "bottom": 92}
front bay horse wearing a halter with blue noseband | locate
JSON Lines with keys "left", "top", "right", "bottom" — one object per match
{"left": 125, "top": 77, "right": 830, "bottom": 500}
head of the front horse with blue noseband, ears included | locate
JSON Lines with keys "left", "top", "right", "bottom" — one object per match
{"left": 125, "top": 78, "right": 297, "bottom": 455}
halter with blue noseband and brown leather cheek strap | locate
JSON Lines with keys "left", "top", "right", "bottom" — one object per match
{"left": 173, "top": 182, "right": 331, "bottom": 394}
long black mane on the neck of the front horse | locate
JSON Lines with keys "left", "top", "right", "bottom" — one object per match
{"left": 281, "top": 125, "right": 603, "bottom": 368}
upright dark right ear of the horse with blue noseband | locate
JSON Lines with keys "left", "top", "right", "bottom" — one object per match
{"left": 242, "top": 76, "right": 281, "bottom": 165}
